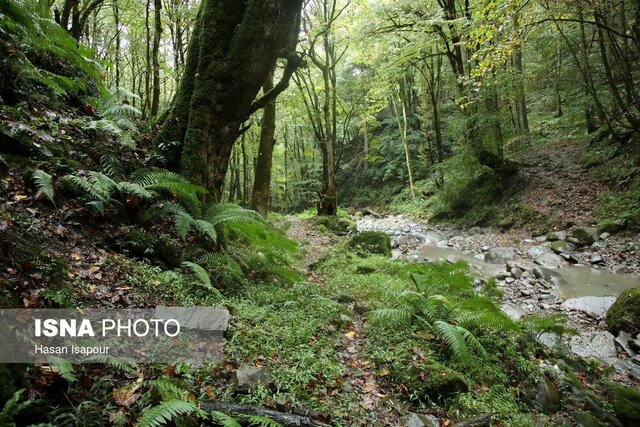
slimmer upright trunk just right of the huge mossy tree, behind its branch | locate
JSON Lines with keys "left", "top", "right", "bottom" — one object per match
{"left": 251, "top": 71, "right": 276, "bottom": 218}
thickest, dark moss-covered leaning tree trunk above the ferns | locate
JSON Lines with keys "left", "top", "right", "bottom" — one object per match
{"left": 156, "top": 0, "right": 302, "bottom": 200}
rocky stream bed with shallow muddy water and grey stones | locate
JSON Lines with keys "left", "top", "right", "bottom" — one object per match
{"left": 357, "top": 215, "right": 640, "bottom": 387}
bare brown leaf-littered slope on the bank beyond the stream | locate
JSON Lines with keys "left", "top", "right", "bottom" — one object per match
{"left": 515, "top": 141, "right": 606, "bottom": 227}
